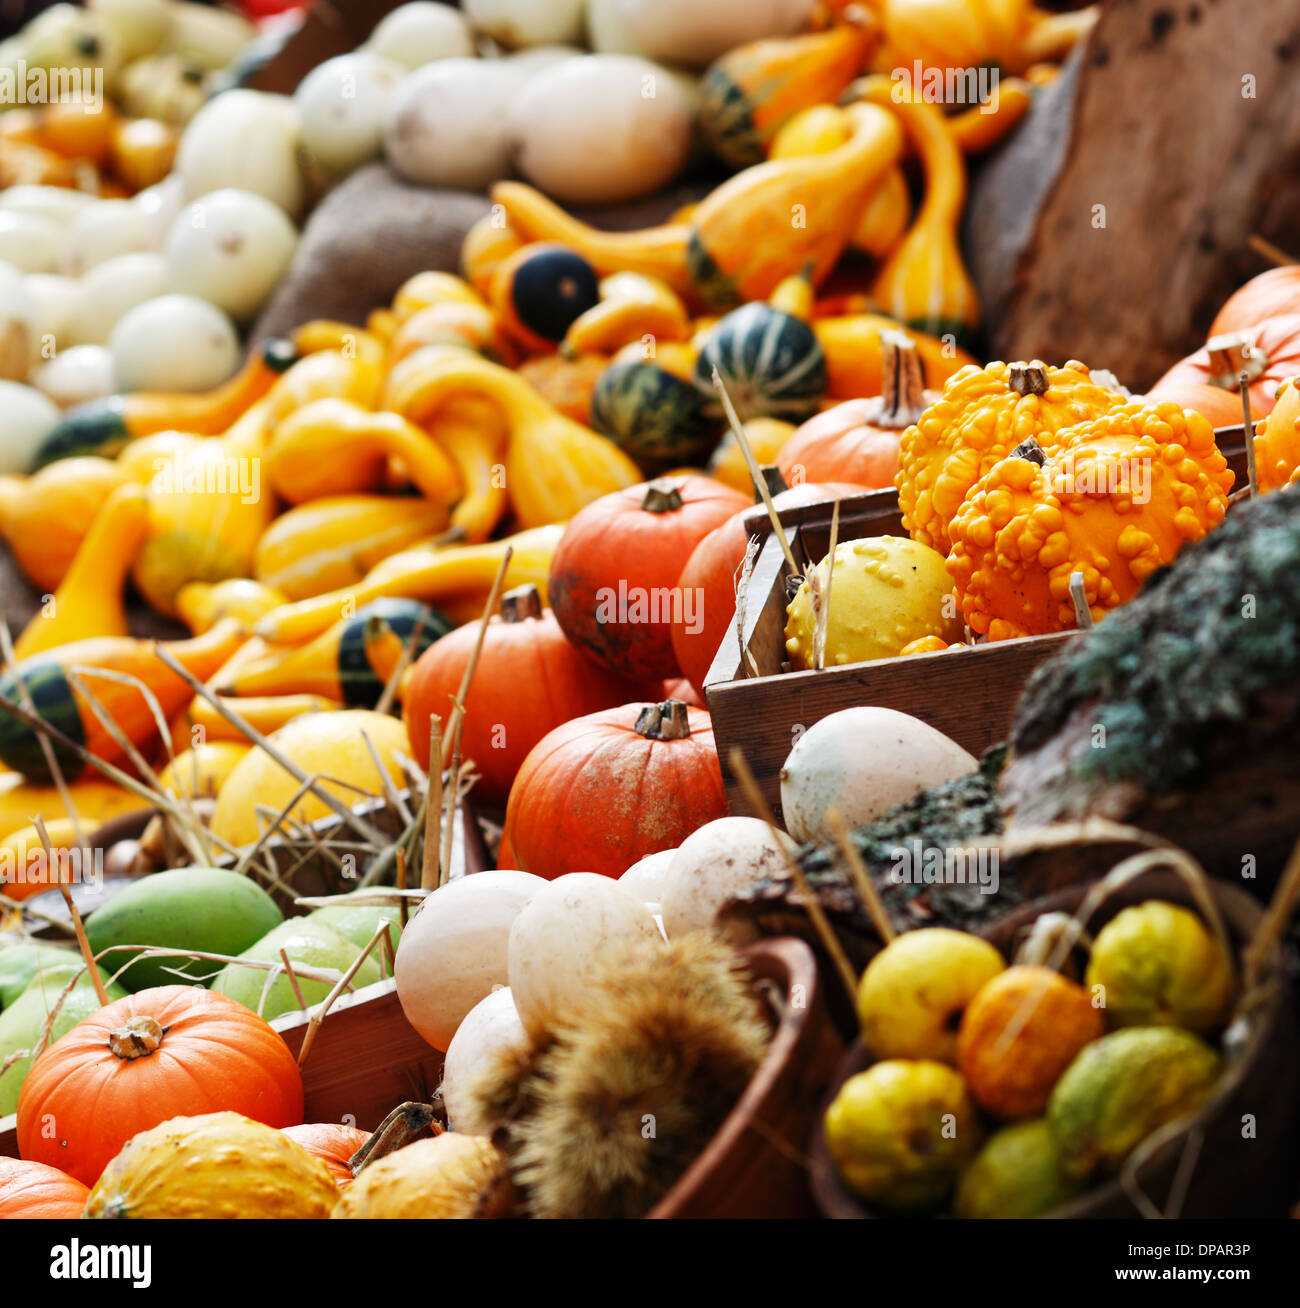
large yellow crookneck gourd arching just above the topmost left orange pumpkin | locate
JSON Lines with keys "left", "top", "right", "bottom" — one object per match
{"left": 385, "top": 347, "right": 641, "bottom": 527}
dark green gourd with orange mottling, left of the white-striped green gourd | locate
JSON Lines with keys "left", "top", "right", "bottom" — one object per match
{"left": 591, "top": 360, "right": 717, "bottom": 471}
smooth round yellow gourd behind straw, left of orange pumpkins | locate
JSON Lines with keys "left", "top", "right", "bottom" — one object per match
{"left": 212, "top": 709, "right": 411, "bottom": 845}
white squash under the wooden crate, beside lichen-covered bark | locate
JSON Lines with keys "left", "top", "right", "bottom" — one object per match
{"left": 781, "top": 706, "right": 980, "bottom": 841}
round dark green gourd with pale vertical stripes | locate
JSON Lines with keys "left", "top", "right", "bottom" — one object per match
{"left": 694, "top": 301, "right": 828, "bottom": 422}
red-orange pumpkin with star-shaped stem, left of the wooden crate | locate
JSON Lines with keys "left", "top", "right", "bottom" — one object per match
{"left": 544, "top": 476, "right": 749, "bottom": 680}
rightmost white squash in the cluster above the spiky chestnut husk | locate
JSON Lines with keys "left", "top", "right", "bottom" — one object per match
{"left": 660, "top": 818, "right": 796, "bottom": 940}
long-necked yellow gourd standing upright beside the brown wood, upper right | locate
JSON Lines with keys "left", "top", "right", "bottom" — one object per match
{"left": 855, "top": 76, "right": 980, "bottom": 348}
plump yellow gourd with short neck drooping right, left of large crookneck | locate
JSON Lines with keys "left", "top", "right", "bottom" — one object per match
{"left": 263, "top": 398, "right": 462, "bottom": 505}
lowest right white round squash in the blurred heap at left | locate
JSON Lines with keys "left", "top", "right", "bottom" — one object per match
{"left": 109, "top": 296, "right": 239, "bottom": 391}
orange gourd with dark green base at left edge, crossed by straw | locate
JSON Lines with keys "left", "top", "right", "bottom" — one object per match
{"left": 0, "top": 621, "right": 245, "bottom": 785}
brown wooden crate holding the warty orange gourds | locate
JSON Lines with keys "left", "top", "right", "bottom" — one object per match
{"left": 705, "top": 426, "right": 1246, "bottom": 814}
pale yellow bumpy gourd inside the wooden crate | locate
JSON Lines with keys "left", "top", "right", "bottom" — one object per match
{"left": 786, "top": 536, "right": 961, "bottom": 668}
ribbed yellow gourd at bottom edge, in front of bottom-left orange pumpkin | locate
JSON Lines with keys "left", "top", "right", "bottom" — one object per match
{"left": 82, "top": 1113, "right": 339, "bottom": 1219}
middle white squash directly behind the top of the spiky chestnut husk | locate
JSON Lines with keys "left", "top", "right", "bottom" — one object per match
{"left": 509, "top": 872, "right": 660, "bottom": 1040}
